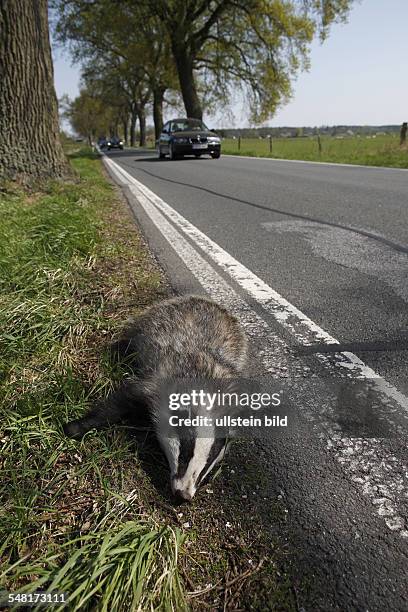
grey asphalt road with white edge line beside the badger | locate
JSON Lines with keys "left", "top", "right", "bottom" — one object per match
{"left": 104, "top": 151, "right": 408, "bottom": 610}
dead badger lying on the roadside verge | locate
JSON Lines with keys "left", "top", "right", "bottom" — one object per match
{"left": 64, "top": 295, "right": 247, "bottom": 501}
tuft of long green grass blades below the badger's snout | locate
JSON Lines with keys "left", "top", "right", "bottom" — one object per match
{"left": 2, "top": 520, "right": 183, "bottom": 611}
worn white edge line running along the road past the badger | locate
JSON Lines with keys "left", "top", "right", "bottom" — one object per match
{"left": 104, "top": 156, "right": 408, "bottom": 537}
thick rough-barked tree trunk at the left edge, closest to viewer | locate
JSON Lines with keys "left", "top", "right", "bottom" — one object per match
{"left": 0, "top": 0, "right": 70, "bottom": 184}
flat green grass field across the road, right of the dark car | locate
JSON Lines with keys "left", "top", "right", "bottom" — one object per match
{"left": 222, "top": 134, "right": 408, "bottom": 168}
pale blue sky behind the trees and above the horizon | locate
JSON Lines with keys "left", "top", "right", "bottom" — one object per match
{"left": 54, "top": 0, "right": 408, "bottom": 128}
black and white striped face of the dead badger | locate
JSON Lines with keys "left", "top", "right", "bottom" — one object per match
{"left": 160, "top": 436, "right": 228, "bottom": 501}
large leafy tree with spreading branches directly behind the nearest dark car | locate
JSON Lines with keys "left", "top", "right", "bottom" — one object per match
{"left": 151, "top": 0, "right": 352, "bottom": 122}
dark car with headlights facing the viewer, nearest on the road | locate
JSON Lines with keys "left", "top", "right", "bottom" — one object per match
{"left": 157, "top": 118, "right": 221, "bottom": 159}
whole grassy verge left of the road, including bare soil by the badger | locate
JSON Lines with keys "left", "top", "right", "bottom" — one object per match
{"left": 0, "top": 149, "right": 294, "bottom": 612}
